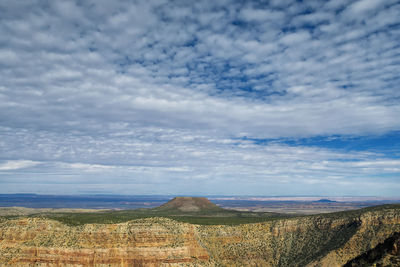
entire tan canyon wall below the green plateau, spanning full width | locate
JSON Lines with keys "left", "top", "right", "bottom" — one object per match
{"left": 0, "top": 207, "right": 400, "bottom": 266}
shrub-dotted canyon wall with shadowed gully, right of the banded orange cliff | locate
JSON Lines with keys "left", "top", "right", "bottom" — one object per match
{"left": 197, "top": 209, "right": 400, "bottom": 267}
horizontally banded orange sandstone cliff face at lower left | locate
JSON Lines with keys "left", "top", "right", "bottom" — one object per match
{"left": 0, "top": 218, "right": 209, "bottom": 266}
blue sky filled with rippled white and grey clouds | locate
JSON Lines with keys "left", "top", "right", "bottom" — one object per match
{"left": 0, "top": 0, "right": 400, "bottom": 197}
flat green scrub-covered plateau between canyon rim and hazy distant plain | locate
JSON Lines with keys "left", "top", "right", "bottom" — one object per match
{"left": 0, "top": 204, "right": 400, "bottom": 226}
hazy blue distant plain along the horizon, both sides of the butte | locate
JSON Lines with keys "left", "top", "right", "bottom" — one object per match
{"left": 0, "top": 194, "right": 400, "bottom": 214}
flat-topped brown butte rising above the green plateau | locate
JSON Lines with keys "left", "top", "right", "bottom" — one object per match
{"left": 157, "top": 197, "right": 222, "bottom": 212}
